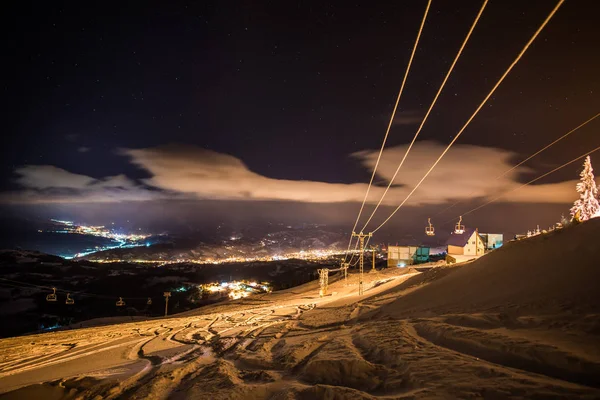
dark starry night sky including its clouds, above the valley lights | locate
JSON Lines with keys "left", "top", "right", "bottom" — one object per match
{"left": 0, "top": 0, "right": 600, "bottom": 238}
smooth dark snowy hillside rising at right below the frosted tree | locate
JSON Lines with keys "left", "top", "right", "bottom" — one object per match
{"left": 385, "top": 219, "right": 600, "bottom": 318}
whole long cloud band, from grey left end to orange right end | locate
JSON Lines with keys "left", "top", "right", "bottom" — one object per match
{"left": 2, "top": 142, "right": 576, "bottom": 206}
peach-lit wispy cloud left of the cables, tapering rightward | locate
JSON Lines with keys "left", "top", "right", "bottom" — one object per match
{"left": 120, "top": 145, "right": 378, "bottom": 203}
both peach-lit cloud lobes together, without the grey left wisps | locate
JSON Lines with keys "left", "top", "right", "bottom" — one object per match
{"left": 121, "top": 142, "right": 574, "bottom": 205}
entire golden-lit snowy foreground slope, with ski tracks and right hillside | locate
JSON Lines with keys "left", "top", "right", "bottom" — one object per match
{"left": 0, "top": 219, "right": 600, "bottom": 399}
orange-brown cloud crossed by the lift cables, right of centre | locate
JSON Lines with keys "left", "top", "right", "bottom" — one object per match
{"left": 352, "top": 141, "right": 576, "bottom": 204}
